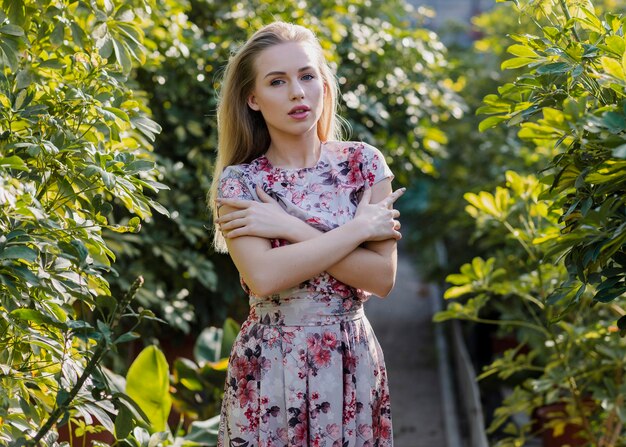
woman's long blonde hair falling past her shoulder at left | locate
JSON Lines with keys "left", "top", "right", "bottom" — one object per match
{"left": 207, "top": 22, "right": 340, "bottom": 253}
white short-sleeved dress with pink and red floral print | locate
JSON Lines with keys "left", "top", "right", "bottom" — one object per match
{"left": 218, "top": 142, "right": 393, "bottom": 447}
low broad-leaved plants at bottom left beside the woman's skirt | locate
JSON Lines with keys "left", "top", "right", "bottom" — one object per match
{"left": 115, "top": 319, "right": 239, "bottom": 447}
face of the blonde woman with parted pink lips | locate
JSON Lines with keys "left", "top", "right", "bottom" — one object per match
{"left": 248, "top": 42, "right": 325, "bottom": 138}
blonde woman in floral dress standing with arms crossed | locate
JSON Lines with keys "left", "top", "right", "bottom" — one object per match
{"left": 209, "top": 22, "right": 403, "bottom": 447}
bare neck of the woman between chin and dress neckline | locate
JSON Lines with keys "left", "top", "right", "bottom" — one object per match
{"left": 265, "top": 132, "right": 321, "bottom": 169}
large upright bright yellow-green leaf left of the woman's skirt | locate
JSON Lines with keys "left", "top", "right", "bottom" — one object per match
{"left": 126, "top": 346, "right": 172, "bottom": 431}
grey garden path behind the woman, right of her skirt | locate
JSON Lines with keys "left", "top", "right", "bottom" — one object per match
{"left": 366, "top": 250, "right": 446, "bottom": 447}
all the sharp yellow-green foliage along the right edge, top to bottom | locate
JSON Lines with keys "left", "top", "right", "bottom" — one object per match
{"left": 437, "top": 0, "right": 626, "bottom": 446}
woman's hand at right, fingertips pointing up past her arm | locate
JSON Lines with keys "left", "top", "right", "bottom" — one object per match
{"left": 354, "top": 188, "right": 406, "bottom": 241}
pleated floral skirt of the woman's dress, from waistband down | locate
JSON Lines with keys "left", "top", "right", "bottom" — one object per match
{"left": 218, "top": 300, "right": 393, "bottom": 447}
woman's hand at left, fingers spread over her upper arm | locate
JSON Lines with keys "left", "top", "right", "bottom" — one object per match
{"left": 215, "top": 185, "right": 301, "bottom": 239}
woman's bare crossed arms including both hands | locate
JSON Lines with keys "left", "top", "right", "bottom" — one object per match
{"left": 217, "top": 179, "right": 404, "bottom": 297}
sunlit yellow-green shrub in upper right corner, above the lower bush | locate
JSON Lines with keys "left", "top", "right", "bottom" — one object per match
{"left": 482, "top": 0, "right": 626, "bottom": 302}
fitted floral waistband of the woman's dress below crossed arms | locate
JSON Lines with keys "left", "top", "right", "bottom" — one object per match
{"left": 248, "top": 297, "right": 365, "bottom": 326}
